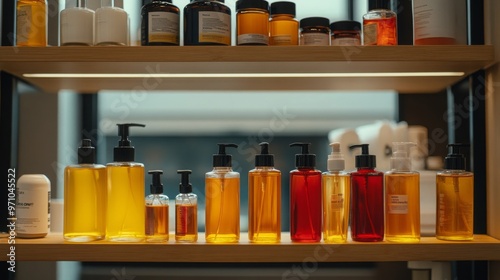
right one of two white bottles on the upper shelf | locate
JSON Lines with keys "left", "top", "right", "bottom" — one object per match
{"left": 95, "top": 0, "right": 129, "bottom": 46}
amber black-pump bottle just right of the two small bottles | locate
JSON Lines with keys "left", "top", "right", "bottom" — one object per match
{"left": 205, "top": 144, "right": 240, "bottom": 243}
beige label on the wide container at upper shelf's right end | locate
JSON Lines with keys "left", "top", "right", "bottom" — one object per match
{"left": 413, "top": 0, "right": 456, "bottom": 40}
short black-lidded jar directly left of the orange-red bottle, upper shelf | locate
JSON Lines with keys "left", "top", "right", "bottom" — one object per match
{"left": 330, "top": 20, "right": 361, "bottom": 46}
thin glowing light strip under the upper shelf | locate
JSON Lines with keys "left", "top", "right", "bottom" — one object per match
{"left": 23, "top": 72, "right": 465, "bottom": 79}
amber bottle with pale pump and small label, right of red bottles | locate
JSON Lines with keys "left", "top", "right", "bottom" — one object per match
{"left": 385, "top": 142, "right": 420, "bottom": 242}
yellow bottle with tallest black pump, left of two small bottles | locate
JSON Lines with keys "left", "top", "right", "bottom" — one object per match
{"left": 106, "top": 123, "right": 146, "bottom": 242}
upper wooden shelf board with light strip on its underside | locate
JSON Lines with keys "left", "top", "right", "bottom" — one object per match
{"left": 0, "top": 46, "right": 494, "bottom": 93}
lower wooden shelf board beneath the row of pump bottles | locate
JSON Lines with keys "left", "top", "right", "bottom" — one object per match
{"left": 0, "top": 232, "right": 500, "bottom": 263}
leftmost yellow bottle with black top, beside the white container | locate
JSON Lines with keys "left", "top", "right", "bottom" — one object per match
{"left": 63, "top": 139, "right": 107, "bottom": 242}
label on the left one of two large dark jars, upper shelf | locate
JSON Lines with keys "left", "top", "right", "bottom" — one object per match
{"left": 148, "top": 12, "right": 179, "bottom": 44}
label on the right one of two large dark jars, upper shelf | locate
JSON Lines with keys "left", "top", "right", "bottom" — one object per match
{"left": 198, "top": 11, "right": 231, "bottom": 45}
